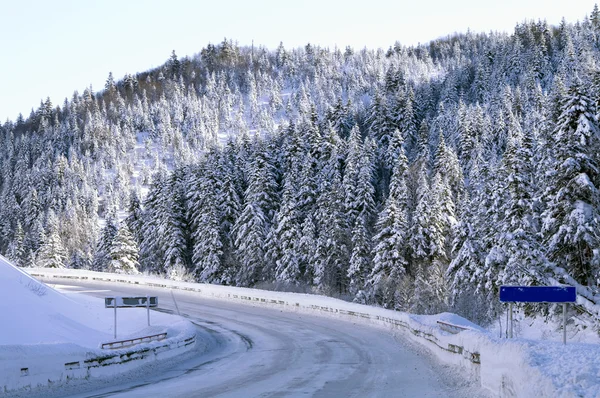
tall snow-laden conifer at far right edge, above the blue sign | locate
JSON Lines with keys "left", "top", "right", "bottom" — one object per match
{"left": 542, "top": 83, "right": 600, "bottom": 285}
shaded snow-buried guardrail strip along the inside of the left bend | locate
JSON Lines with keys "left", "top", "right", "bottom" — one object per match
{"left": 0, "top": 310, "right": 196, "bottom": 396}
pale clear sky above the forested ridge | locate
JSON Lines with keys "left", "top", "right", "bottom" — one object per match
{"left": 0, "top": 0, "right": 597, "bottom": 122}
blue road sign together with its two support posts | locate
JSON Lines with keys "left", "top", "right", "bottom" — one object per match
{"left": 500, "top": 286, "right": 577, "bottom": 344}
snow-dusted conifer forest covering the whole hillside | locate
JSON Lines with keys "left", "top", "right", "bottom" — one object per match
{"left": 0, "top": 7, "right": 600, "bottom": 328}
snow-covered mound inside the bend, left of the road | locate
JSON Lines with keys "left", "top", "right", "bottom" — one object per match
{"left": 0, "top": 256, "right": 195, "bottom": 395}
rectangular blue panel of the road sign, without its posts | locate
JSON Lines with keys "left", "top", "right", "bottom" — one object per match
{"left": 500, "top": 286, "right": 577, "bottom": 303}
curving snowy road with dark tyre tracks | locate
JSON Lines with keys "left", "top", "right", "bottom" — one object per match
{"left": 48, "top": 281, "right": 482, "bottom": 397}
